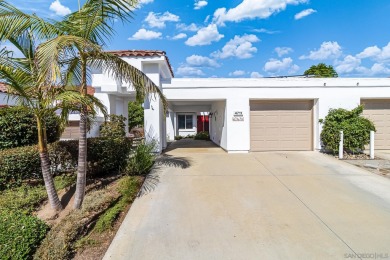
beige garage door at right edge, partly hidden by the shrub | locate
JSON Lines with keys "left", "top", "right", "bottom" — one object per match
{"left": 361, "top": 99, "right": 390, "bottom": 150}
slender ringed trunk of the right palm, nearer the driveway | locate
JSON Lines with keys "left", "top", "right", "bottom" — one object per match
{"left": 73, "top": 59, "right": 88, "bottom": 209}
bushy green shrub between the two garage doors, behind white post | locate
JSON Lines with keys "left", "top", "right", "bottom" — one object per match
{"left": 320, "top": 106, "right": 375, "bottom": 153}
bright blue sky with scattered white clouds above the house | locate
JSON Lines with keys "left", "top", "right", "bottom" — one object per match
{"left": 4, "top": 0, "right": 390, "bottom": 78}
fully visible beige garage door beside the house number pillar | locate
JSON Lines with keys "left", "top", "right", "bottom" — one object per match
{"left": 250, "top": 100, "right": 313, "bottom": 151}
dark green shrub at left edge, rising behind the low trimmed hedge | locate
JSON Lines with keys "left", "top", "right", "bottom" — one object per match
{"left": 0, "top": 107, "right": 61, "bottom": 149}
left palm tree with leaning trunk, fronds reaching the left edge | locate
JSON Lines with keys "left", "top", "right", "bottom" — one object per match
{"left": 0, "top": 30, "right": 104, "bottom": 210}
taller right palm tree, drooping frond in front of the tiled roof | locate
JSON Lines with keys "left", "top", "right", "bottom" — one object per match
{"left": 40, "top": 0, "right": 166, "bottom": 209}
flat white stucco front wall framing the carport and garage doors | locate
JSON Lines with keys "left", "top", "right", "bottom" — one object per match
{"left": 163, "top": 78, "right": 390, "bottom": 152}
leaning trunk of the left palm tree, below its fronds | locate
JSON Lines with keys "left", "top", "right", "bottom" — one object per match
{"left": 37, "top": 117, "right": 62, "bottom": 211}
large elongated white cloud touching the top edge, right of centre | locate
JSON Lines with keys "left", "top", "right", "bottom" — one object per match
{"left": 214, "top": 0, "right": 308, "bottom": 24}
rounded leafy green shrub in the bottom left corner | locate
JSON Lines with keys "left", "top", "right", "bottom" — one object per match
{"left": 0, "top": 211, "right": 49, "bottom": 260}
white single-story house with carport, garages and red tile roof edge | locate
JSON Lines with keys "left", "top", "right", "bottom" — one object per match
{"left": 0, "top": 50, "right": 390, "bottom": 153}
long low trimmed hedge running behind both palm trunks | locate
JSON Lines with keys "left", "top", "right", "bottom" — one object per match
{"left": 0, "top": 137, "right": 132, "bottom": 190}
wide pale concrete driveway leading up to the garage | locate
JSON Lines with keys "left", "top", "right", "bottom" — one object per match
{"left": 104, "top": 141, "right": 390, "bottom": 259}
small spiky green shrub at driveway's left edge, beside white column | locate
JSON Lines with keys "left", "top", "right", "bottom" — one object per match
{"left": 125, "top": 143, "right": 156, "bottom": 175}
